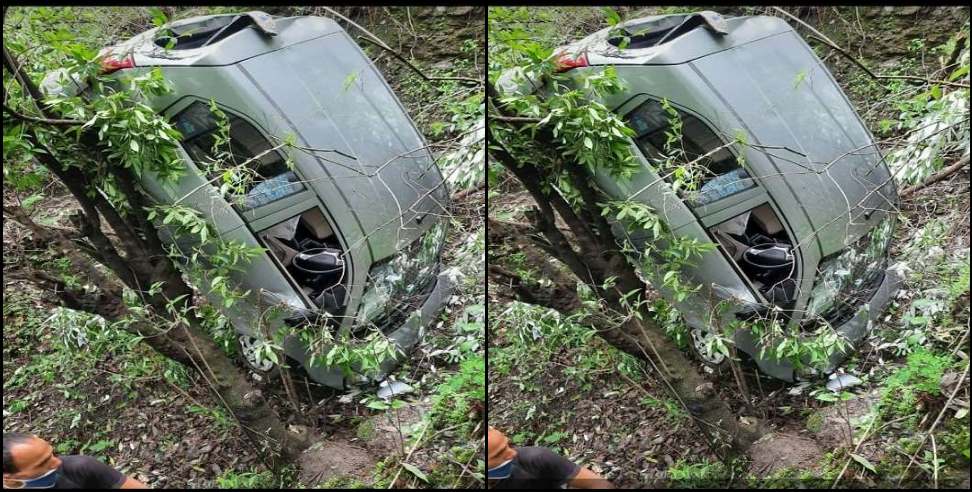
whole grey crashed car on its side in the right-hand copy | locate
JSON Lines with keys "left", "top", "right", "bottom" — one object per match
{"left": 497, "top": 11, "right": 899, "bottom": 381}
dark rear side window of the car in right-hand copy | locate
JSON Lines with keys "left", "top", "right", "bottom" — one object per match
{"left": 625, "top": 100, "right": 755, "bottom": 206}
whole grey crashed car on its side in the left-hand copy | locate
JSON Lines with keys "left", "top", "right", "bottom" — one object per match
{"left": 44, "top": 12, "right": 451, "bottom": 388}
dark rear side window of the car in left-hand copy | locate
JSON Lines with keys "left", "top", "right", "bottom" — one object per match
{"left": 174, "top": 102, "right": 305, "bottom": 209}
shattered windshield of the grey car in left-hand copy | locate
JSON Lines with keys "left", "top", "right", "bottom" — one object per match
{"left": 357, "top": 220, "right": 446, "bottom": 326}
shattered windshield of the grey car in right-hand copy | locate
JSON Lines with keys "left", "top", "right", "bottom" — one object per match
{"left": 807, "top": 214, "right": 894, "bottom": 322}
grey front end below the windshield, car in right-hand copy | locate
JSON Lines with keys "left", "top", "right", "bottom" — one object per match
{"left": 736, "top": 268, "right": 901, "bottom": 382}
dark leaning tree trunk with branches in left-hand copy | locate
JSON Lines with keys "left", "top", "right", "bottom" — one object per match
{"left": 3, "top": 46, "right": 311, "bottom": 461}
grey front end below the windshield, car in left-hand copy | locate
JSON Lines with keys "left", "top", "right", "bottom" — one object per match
{"left": 285, "top": 273, "right": 452, "bottom": 389}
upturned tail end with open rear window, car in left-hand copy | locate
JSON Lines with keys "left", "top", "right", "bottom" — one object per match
{"left": 100, "top": 12, "right": 343, "bottom": 67}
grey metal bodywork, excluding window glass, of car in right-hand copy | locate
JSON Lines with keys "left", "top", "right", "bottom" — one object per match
{"left": 497, "top": 12, "right": 899, "bottom": 380}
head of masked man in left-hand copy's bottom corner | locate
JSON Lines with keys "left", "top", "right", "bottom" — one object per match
{"left": 3, "top": 432, "right": 61, "bottom": 489}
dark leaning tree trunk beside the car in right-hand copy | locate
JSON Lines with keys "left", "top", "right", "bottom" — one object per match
{"left": 487, "top": 86, "right": 762, "bottom": 452}
